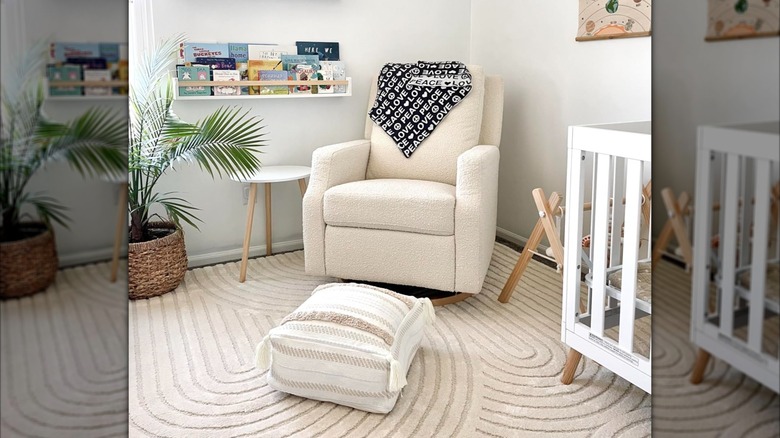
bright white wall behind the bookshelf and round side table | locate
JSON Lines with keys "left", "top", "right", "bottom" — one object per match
{"left": 149, "top": 0, "right": 470, "bottom": 265}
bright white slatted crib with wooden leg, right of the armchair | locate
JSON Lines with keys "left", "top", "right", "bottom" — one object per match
{"left": 561, "top": 121, "right": 652, "bottom": 393}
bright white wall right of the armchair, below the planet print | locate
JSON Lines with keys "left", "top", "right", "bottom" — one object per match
{"left": 471, "top": 0, "right": 656, "bottom": 245}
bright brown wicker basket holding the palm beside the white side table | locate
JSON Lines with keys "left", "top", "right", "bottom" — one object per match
{"left": 127, "top": 222, "right": 187, "bottom": 300}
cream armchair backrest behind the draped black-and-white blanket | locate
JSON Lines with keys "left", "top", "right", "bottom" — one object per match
{"left": 365, "top": 65, "right": 504, "bottom": 185}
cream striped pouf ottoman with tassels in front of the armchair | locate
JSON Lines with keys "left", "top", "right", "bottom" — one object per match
{"left": 256, "top": 283, "right": 435, "bottom": 413}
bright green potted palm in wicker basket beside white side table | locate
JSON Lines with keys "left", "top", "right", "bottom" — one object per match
{"left": 128, "top": 36, "right": 265, "bottom": 299}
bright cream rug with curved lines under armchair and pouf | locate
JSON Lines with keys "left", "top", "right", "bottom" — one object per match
{"left": 129, "top": 244, "right": 650, "bottom": 437}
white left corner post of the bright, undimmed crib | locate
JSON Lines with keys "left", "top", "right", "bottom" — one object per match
{"left": 561, "top": 139, "right": 585, "bottom": 334}
